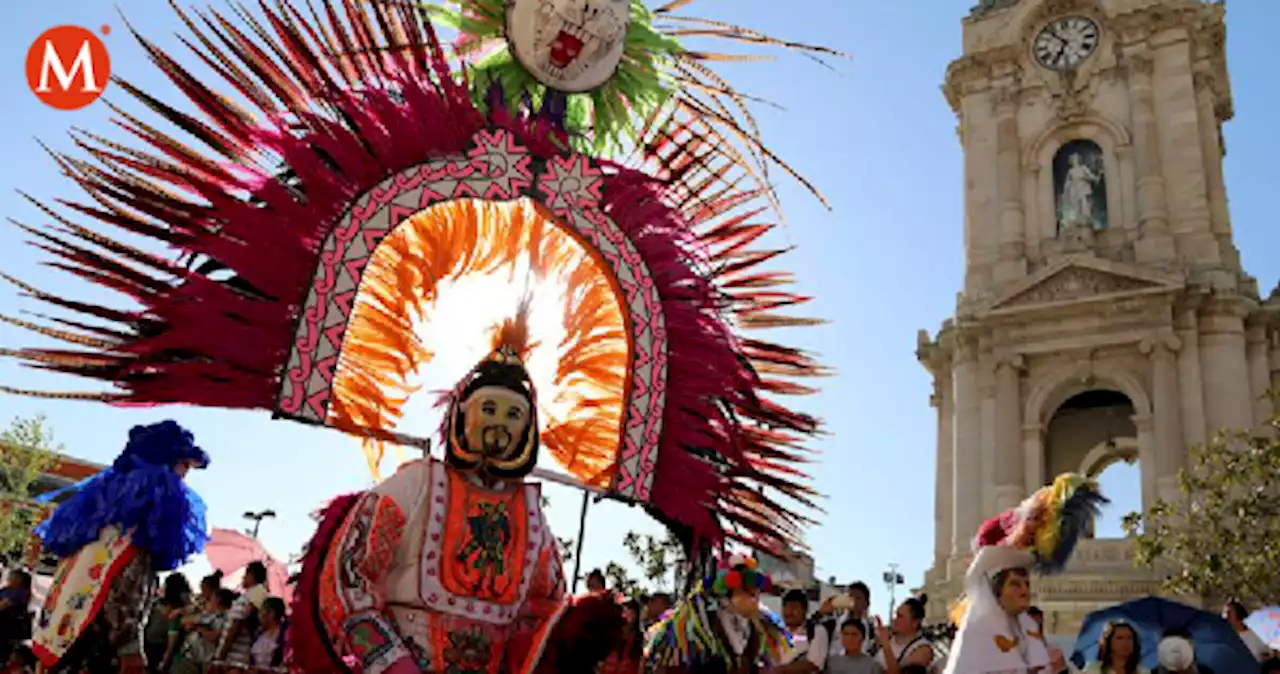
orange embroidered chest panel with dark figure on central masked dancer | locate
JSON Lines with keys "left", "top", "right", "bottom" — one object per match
{"left": 439, "top": 471, "right": 527, "bottom": 605}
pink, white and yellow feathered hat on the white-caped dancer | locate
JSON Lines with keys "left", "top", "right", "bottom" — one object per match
{"left": 973, "top": 473, "right": 1110, "bottom": 574}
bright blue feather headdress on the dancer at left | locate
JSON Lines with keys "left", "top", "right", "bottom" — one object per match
{"left": 36, "top": 421, "right": 209, "bottom": 570}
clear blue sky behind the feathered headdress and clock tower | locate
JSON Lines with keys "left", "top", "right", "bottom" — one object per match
{"left": 0, "top": 0, "right": 1280, "bottom": 606}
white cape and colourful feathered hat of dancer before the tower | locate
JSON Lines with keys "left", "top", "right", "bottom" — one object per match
{"left": 945, "top": 473, "right": 1107, "bottom": 674}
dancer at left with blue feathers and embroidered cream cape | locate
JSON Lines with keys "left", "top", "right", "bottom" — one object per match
{"left": 32, "top": 421, "right": 209, "bottom": 673}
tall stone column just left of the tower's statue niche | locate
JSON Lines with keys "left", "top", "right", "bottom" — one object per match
{"left": 995, "top": 82, "right": 1027, "bottom": 284}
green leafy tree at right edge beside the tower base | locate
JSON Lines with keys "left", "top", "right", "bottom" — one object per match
{"left": 1124, "top": 417, "right": 1280, "bottom": 604}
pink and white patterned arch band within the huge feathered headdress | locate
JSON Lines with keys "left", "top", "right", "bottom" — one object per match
{"left": 275, "top": 129, "right": 668, "bottom": 501}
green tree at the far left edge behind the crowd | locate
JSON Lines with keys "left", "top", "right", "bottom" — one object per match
{"left": 0, "top": 414, "right": 63, "bottom": 561}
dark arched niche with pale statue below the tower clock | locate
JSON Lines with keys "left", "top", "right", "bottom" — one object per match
{"left": 1053, "top": 139, "right": 1107, "bottom": 235}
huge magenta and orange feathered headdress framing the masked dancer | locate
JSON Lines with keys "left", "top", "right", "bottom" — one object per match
{"left": 5, "top": 0, "right": 820, "bottom": 557}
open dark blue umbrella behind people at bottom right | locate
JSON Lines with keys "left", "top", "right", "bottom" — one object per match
{"left": 1071, "top": 597, "right": 1258, "bottom": 674}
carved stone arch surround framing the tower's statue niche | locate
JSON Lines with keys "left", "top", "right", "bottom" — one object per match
{"left": 1023, "top": 115, "right": 1135, "bottom": 240}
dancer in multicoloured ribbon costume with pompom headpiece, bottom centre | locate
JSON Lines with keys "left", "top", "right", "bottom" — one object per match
{"left": 644, "top": 555, "right": 791, "bottom": 674}
